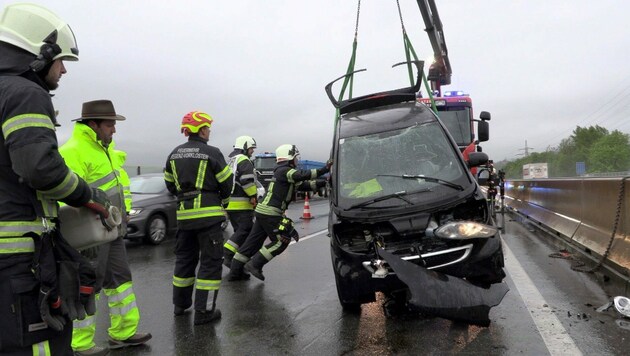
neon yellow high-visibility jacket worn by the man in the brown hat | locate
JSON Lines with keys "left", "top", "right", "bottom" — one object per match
{"left": 59, "top": 122, "right": 131, "bottom": 236}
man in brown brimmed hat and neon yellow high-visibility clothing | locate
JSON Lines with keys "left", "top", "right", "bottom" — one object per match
{"left": 59, "top": 100, "right": 151, "bottom": 355}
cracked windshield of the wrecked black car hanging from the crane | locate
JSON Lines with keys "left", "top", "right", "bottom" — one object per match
{"left": 337, "top": 121, "right": 469, "bottom": 208}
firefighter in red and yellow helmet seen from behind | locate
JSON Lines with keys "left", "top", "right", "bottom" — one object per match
{"left": 164, "top": 111, "right": 232, "bottom": 325}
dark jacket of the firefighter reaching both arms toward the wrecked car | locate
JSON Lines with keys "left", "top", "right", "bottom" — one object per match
{"left": 255, "top": 162, "right": 329, "bottom": 216}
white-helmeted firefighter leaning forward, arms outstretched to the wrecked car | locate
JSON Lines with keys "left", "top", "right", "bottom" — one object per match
{"left": 228, "top": 144, "right": 332, "bottom": 281}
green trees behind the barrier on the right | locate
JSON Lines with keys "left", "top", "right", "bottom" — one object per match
{"left": 495, "top": 125, "right": 630, "bottom": 179}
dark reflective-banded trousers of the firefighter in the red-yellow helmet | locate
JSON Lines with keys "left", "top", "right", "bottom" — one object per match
{"left": 173, "top": 222, "right": 223, "bottom": 310}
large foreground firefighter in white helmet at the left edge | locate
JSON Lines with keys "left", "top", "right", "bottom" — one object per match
{"left": 0, "top": 4, "right": 108, "bottom": 355}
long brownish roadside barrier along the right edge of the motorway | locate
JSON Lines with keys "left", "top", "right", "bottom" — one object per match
{"left": 505, "top": 178, "right": 630, "bottom": 277}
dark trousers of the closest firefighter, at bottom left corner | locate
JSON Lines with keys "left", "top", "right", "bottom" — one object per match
{"left": 0, "top": 253, "right": 74, "bottom": 356}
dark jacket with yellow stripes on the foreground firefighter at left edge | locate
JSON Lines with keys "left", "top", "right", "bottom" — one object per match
{"left": 0, "top": 42, "right": 91, "bottom": 258}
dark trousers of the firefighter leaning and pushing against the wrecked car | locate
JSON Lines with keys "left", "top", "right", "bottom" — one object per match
{"left": 238, "top": 213, "right": 289, "bottom": 262}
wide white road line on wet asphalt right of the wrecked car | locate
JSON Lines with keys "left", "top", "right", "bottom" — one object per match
{"left": 503, "top": 241, "right": 582, "bottom": 356}
